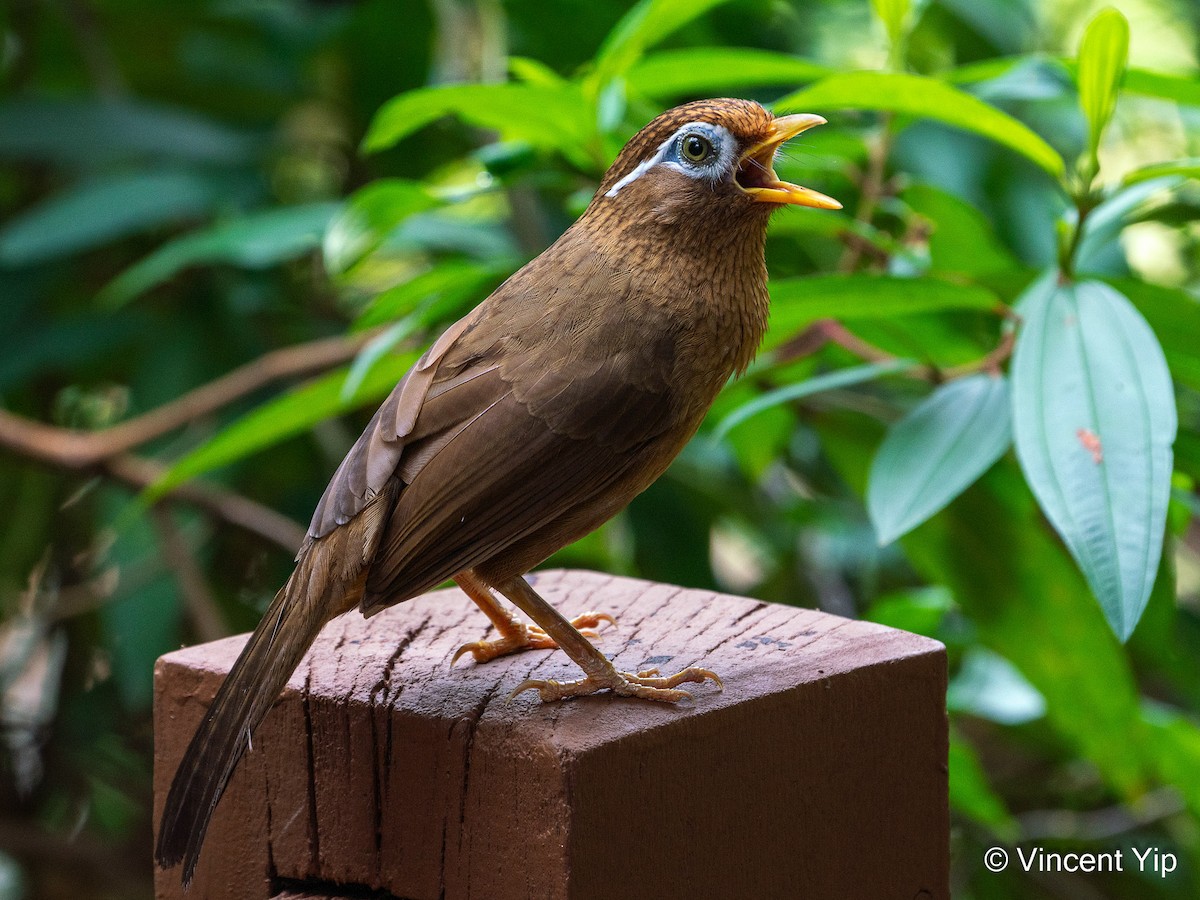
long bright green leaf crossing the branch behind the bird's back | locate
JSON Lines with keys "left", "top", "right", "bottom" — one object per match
{"left": 143, "top": 350, "right": 420, "bottom": 503}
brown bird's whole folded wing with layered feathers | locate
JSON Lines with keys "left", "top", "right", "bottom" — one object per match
{"left": 308, "top": 271, "right": 676, "bottom": 612}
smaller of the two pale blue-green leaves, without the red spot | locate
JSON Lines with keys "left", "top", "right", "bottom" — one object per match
{"left": 866, "top": 374, "right": 1012, "bottom": 545}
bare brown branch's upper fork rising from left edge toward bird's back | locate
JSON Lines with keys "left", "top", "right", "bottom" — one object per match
{"left": 0, "top": 331, "right": 377, "bottom": 469}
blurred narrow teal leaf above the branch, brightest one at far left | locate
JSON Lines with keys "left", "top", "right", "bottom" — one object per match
{"left": 98, "top": 203, "right": 342, "bottom": 308}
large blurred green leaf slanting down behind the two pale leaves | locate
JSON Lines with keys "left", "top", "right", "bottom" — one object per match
{"left": 817, "top": 414, "right": 1148, "bottom": 797}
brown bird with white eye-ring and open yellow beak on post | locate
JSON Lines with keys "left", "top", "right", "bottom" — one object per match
{"left": 155, "top": 100, "right": 840, "bottom": 884}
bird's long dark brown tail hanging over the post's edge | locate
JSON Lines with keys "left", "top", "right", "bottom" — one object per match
{"left": 155, "top": 547, "right": 356, "bottom": 886}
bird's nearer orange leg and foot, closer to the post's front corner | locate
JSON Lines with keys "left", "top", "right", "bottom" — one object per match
{"left": 496, "top": 576, "right": 724, "bottom": 703}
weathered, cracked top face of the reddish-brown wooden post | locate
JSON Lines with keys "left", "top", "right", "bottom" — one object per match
{"left": 157, "top": 569, "right": 944, "bottom": 752}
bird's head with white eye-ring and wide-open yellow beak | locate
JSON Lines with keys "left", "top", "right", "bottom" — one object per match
{"left": 589, "top": 100, "right": 841, "bottom": 227}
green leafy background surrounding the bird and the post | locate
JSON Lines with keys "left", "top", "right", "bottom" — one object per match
{"left": 0, "top": 0, "right": 1200, "bottom": 898}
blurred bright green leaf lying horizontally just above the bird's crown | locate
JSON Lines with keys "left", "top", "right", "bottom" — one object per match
{"left": 625, "top": 47, "right": 830, "bottom": 100}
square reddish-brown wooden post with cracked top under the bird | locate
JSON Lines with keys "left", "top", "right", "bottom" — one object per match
{"left": 155, "top": 571, "right": 949, "bottom": 900}
